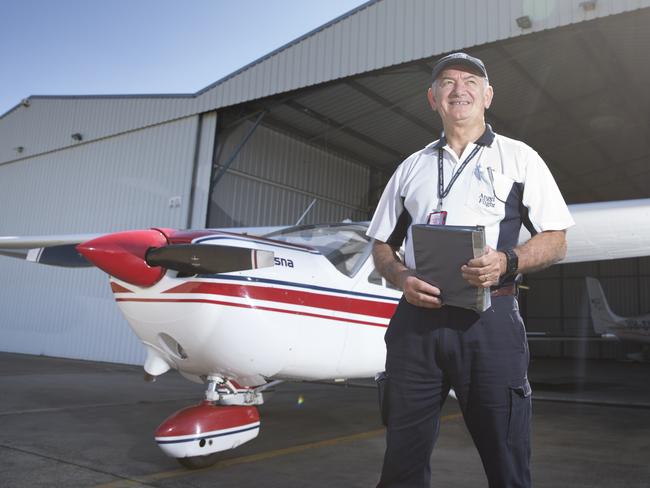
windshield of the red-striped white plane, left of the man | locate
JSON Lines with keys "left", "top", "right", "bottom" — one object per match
{"left": 264, "top": 223, "right": 370, "bottom": 276}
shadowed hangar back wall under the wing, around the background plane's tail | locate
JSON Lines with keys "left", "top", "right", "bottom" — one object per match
{"left": 522, "top": 257, "right": 650, "bottom": 359}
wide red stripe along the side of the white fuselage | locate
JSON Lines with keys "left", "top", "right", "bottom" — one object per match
{"left": 164, "top": 281, "right": 396, "bottom": 319}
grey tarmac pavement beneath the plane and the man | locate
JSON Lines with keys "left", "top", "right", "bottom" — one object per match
{"left": 0, "top": 353, "right": 650, "bottom": 488}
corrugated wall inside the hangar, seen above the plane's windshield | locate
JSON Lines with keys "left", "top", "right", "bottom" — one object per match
{"left": 208, "top": 119, "right": 370, "bottom": 227}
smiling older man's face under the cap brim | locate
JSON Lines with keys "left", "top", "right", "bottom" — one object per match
{"left": 427, "top": 66, "right": 493, "bottom": 123}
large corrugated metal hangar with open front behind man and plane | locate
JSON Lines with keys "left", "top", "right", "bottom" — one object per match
{"left": 0, "top": 0, "right": 650, "bottom": 363}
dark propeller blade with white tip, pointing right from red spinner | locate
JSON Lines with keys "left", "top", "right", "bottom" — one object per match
{"left": 146, "top": 244, "right": 274, "bottom": 275}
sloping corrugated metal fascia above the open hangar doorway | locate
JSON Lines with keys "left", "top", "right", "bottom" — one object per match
{"left": 196, "top": 0, "right": 650, "bottom": 107}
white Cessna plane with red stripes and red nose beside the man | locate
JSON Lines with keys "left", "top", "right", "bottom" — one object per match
{"left": 0, "top": 199, "right": 650, "bottom": 468}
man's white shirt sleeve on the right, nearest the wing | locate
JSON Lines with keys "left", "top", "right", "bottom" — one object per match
{"left": 522, "top": 148, "right": 575, "bottom": 233}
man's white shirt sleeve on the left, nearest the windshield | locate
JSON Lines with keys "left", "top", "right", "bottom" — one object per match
{"left": 366, "top": 164, "right": 411, "bottom": 247}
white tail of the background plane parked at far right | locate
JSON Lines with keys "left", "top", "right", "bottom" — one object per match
{"left": 585, "top": 277, "right": 650, "bottom": 344}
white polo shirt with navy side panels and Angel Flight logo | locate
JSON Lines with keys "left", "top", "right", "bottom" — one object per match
{"left": 367, "top": 125, "right": 574, "bottom": 268}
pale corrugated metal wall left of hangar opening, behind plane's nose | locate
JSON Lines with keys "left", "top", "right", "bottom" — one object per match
{"left": 0, "top": 114, "right": 208, "bottom": 363}
